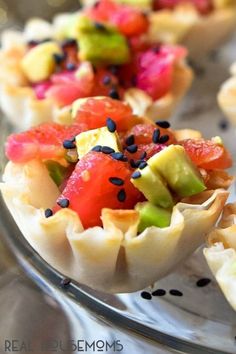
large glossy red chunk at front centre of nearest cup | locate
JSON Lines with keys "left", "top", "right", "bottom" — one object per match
{"left": 55, "top": 152, "right": 143, "bottom": 228}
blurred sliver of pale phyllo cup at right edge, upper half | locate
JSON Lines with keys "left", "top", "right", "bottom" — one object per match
{"left": 218, "top": 63, "right": 236, "bottom": 124}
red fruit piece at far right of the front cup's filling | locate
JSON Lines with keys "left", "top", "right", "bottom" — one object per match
{"left": 180, "top": 139, "right": 232, "bottom": 170}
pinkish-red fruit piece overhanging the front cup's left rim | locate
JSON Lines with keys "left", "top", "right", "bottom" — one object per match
{"left": 6, "top": 123, "right": 87, "bottom": 163}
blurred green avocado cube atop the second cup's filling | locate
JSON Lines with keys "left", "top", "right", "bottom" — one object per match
{"left": 79, "top": 29, "right": 130, "bottom": 65}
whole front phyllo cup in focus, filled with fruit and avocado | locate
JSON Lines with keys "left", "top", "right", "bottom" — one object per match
{"left": 0, "top": 97, "right": 232, "bottom": 293}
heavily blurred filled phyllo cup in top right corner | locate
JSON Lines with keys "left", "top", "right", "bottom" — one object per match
{"left": 84, "top": 0, "right": 236, "bottom": 59}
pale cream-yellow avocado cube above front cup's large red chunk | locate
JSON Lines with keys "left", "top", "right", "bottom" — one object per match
{"left": 75, "top": 127, "right": 120, "bottom": 159}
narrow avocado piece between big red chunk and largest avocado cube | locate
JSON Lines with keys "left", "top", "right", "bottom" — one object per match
{"left": 131, "top": 166, "right": 173, "bottom": 208}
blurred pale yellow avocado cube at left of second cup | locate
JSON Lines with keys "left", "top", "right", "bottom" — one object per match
{"left": 21, "top": 42, "right": 62, "bottom": 82}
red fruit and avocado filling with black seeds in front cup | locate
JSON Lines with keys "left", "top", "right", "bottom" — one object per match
{"left": 6, "top": 97, "right": 232, "bottom": 232}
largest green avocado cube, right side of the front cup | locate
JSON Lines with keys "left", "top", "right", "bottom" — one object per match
{"left": 148, "top": 145, "right": 206, "bottom": 197}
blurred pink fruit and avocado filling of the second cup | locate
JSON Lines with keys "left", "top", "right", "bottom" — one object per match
{"left": 21, "top": 0, "right": 190, "bottom": 107}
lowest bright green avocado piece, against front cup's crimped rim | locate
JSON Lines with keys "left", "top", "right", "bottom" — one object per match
{"left": 135, "top": 202, "right": 172, "bottom": 232}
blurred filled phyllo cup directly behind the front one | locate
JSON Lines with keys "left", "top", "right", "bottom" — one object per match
{"left": 0, "top": 0, "right": 192, "bottom": 129}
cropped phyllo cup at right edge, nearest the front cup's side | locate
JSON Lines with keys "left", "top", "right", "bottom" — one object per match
{"left": 204, "top": 203, "right": 236, "bottom": 311}
